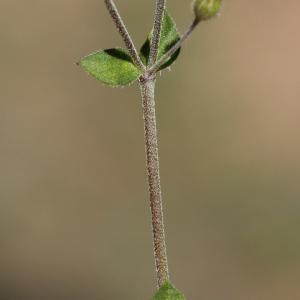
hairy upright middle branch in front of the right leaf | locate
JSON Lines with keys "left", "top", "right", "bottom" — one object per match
{"left": 149, "top": 0, "right": 166, "bottom": 66}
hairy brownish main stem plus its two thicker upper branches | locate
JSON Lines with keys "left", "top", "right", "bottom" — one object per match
{"left": 104, "top": 0, "right": 169, "bottom": 287}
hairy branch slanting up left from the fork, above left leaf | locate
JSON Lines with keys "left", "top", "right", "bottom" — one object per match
{"left": 104, "top": 0, "right": 145, "bottom": 71}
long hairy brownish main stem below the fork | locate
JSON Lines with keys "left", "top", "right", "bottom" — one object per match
{"left": 140, "top": 78, "right": 169, "bottom": 287}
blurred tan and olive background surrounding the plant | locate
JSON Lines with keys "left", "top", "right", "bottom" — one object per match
{"left": 0, "top": 0, "right": 300, "bottom": 300}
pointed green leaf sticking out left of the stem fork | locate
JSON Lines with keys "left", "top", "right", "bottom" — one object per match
{"left": 78, "top": 48, "right": 141, "bottom": 86}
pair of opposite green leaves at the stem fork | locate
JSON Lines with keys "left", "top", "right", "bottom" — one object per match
{"left": 79, "top": 11, "right": 180, "bottom": 86}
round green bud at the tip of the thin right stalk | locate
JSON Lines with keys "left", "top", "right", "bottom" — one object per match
{"left": 193, "top": 0, "right": 222, "bottom": 21}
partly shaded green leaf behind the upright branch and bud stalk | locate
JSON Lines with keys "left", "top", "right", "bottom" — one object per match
{"left": 140, "top": 10, "right": 180, "bottom": 70}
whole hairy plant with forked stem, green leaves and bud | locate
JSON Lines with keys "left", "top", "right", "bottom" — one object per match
{"left": 78, "top": 0, "right": 222, "bottom": 300}
